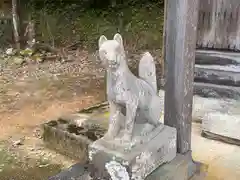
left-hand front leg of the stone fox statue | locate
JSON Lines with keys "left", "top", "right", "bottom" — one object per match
{"left": 105, "top": 101, "right": 121, "bottom": 139}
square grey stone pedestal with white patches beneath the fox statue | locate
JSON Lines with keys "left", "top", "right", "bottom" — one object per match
{"left": 89, "top": 126, "right": 176, "bottom": 180}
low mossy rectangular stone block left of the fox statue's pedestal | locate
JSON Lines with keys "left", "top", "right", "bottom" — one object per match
{"left": 42, "top": 118, "right": 106, "bottom": 162}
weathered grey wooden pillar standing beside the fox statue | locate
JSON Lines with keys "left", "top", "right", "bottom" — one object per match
{"left": 164, "top": 0, "right": 199, "bottom": 153}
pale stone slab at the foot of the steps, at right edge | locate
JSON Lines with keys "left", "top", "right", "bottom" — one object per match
{"left": 202, "top": 112, "right": 240, "bottom": 145}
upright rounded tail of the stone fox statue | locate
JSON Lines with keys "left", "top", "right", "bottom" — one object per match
{"left": 138, "top": 52, "right": 157, "bottom": 93}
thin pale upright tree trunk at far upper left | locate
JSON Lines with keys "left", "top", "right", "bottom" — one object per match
{"left": 12, "top": 0, "right": 21, "bottom": 50}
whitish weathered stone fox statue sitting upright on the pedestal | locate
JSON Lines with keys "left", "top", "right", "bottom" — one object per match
{"left": 98, "top": 34, "right": 161, "bottom": 141}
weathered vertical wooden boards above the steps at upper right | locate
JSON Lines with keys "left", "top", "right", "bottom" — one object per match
{"left": 197, "top": 0, "right": 240, "bottom": 51}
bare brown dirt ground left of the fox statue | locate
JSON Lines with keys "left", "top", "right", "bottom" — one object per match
{"left": 0, "top": 52, "right": 105, "bottom": 180}
